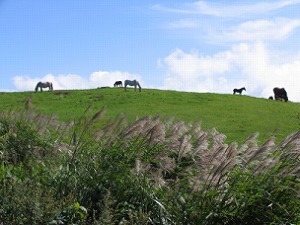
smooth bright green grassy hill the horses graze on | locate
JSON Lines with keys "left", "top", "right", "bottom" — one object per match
{"left": 0, "top": 88, "right": 300, "bottom": 142}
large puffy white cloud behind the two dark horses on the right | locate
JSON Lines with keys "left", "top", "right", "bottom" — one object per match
{"left": 161, "top": 42, "right": 300, "bottom": 101}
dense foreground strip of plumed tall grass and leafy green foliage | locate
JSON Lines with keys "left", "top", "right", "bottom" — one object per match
{"left": 0, "top": 107, "right": 300, "bottom": 225}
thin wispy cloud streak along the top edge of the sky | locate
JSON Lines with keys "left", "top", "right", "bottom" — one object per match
{"left": 152, "top": 0, "right": 300, "bottom": 17}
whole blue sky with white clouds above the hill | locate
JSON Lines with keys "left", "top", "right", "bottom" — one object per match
{"left": 0, "top": 0, "right": 300, "bottom": 102}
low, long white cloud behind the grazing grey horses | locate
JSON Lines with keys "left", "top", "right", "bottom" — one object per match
{"left": 13, "top": 71, "right": 143, "bottom": 91}
